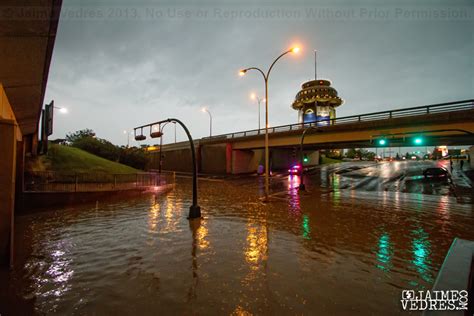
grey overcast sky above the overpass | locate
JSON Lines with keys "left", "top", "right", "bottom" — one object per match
{"left": 45, "top": 0, "right": 474, "bottom": 144}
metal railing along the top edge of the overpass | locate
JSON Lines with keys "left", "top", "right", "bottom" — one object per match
{"left": 202, "top": 100, "right": 474, "bottom": 140}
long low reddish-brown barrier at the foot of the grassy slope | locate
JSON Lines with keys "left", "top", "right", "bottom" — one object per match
{"left": 24, "top": 171, "right": 174, "bottom": 192}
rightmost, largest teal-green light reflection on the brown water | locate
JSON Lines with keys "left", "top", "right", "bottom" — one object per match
{"left": 412, "top": 228, "right": 433, "bottom": 282}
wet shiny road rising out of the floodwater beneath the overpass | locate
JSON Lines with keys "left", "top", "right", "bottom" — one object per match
{"left": 268, "top": 160, "right": 473, "bottom": 203}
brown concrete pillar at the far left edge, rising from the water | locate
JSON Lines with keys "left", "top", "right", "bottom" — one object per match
{"left": 0, "top": 119, "right": 17, "bottom": 265}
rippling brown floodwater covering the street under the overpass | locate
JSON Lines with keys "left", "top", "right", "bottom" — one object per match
{"left": 3, "top": 164, "right": 474, "bottom": 315}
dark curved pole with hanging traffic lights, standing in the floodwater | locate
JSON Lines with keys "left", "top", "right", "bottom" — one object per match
{"left": 134, "top": 118, "right": 201, "bottom": 219}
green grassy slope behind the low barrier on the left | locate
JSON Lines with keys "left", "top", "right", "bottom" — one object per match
{"left": 26, "top": 145, "right": 141, "bottom": 173}
